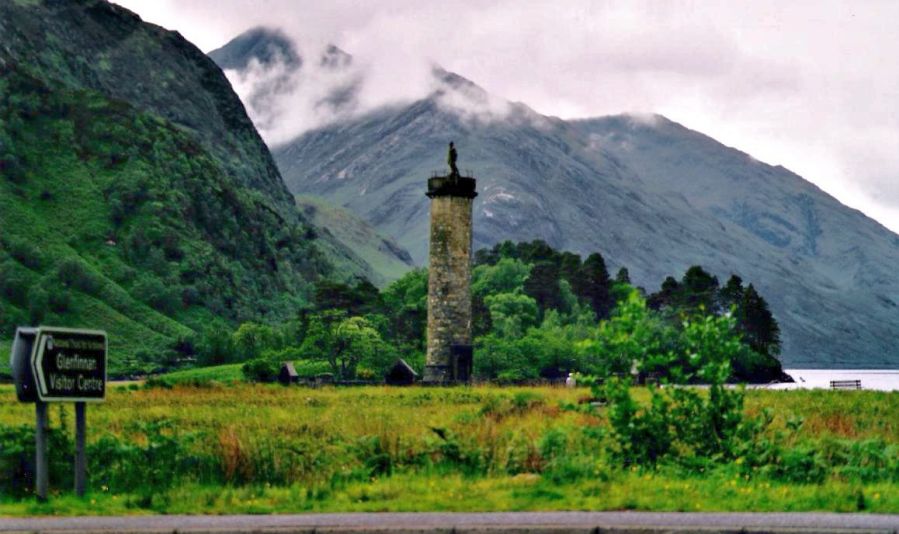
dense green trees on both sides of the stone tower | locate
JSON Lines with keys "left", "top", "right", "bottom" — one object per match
{"left": 207, "top": 241, "right": 782, "bottom": 382}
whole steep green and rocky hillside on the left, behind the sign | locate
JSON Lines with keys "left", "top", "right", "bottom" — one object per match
{"left": 0, "top": 0, "right": 370, "bottom": 372}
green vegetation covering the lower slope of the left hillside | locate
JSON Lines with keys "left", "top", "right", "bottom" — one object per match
{"left": 0, "top": 59, "right": 333, "bottom": 373}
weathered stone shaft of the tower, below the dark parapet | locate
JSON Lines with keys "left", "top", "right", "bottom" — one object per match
{"left": 424, "top": 193, "right": 473, "bottom": 382}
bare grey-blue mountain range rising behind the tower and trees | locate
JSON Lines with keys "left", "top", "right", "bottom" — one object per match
{"left": 212, "top": 28, "right": 899, "bottom": 368}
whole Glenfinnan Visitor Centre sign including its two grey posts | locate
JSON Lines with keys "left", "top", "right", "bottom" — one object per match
{"left": 10, "top": 326, "right": 107, "bottom": 500}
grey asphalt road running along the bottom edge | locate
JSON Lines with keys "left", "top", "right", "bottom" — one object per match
{"left": 0, "top": 512, "right": 899, "bottom": 534}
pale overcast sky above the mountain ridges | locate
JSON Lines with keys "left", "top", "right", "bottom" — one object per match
{"left": 117, "top": 0, "right": 899, "bottom": 232}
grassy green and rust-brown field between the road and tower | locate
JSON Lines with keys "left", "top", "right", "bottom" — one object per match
{"left": 0, "top": 386, "right": 899, "bottom": 515}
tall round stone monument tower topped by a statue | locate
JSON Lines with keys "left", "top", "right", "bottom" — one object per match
{"left": 423, "top": 143, "right": 478, "bottom": 384}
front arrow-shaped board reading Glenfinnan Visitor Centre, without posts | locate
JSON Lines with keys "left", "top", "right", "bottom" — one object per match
{"left": 31, "top": 326, "right": 107, "bottom": 402}
